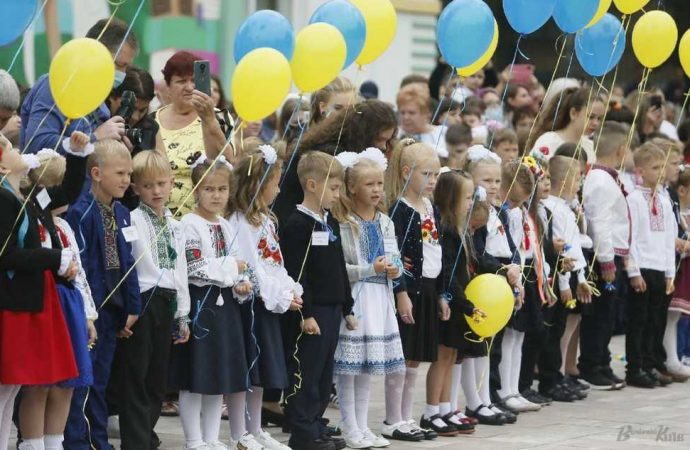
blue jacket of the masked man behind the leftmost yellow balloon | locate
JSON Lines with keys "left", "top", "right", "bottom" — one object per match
{"left": 19, "top": 75, "right": 110, "bottom": 153}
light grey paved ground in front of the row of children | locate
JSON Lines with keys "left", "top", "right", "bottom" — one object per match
{"left": 11, "top": 336, "right": 690, "bottom": 450}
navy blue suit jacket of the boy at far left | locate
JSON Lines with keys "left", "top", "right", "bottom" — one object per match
{"left": 65, "top": 191, "right": 141, "bottom": 315}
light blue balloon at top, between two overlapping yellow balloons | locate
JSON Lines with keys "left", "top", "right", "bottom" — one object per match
{"left": 309, "top": 0, "right": 367, "bottom": 69}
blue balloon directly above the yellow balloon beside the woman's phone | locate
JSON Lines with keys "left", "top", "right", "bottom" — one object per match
{"left": 235, "top": 9, "right": 295, "bottom": 63}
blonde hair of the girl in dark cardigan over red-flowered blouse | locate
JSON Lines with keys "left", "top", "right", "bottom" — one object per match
{"left": 385, "top": 139, "right": 438, "bottom": 207}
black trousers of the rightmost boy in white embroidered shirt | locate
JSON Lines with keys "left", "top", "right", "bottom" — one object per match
{"left": 625, "top": 269, "right": 668, "bottom": 373}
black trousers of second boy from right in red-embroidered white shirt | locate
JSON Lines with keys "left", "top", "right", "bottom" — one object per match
{"left": 578, "top": 256, "right": 628, "bottom": 375}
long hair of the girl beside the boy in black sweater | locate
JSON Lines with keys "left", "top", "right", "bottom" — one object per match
{"left": 228, "top": 151, "right": 283, "bottom": 226}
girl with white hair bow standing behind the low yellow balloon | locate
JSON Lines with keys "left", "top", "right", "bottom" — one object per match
{"left": 460, "top": 145, "right": 520, "bottom": 425}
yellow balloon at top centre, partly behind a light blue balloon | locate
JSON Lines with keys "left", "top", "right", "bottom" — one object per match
{"left": 350, "top": 0, "right": 398, "bottom": 66}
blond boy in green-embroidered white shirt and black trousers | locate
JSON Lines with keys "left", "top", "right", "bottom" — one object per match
{"left": 115, "top": 151, "right": 189, "bottom": 450}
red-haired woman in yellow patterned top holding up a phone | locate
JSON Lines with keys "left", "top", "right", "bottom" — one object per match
{"left": 154, "top": 51, "right": 234, "bottom": 214}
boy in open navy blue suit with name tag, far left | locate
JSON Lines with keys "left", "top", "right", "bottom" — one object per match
{"left": 64, "top": 139, "right": 141, "bottom": 450}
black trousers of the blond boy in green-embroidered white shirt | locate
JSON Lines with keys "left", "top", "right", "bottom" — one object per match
{"left": 117, "top": 288, "right": 175, "bottom": 450}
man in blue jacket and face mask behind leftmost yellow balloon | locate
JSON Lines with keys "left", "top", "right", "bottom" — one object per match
{"left": 19, "top": 18, "right": 139, "bottom": 153}
